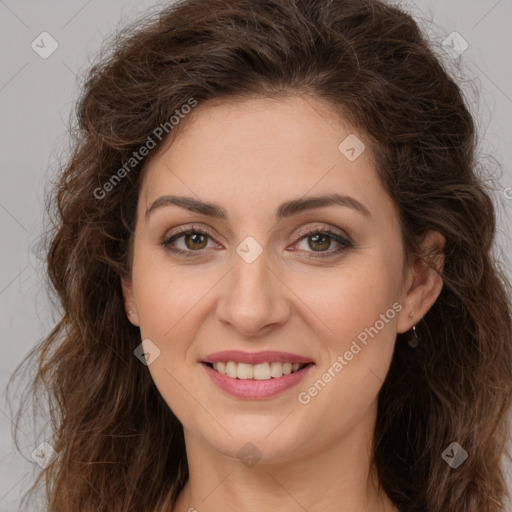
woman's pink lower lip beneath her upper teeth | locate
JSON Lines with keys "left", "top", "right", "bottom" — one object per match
{"left": 201, "top": 363, "right": 314, "bottom": 400}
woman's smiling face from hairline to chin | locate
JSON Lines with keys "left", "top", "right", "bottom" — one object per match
{"left": 123, "top": 96, "right": 440, "bottom": 461}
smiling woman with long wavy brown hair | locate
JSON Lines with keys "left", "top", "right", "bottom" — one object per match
{"left": 11, "top": 0, "right": 512, "bottom": 512}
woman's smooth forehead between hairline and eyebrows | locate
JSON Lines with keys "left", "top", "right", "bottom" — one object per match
{"left": 137, "top": 96, "right": 393, "bottom": 226}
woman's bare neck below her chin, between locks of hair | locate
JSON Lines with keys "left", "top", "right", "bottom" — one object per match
{"left": 173, "top": 400, "right": 397, "bottom": 512}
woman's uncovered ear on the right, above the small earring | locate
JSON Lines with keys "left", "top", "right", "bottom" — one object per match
{"left": 397, "top": 231, "right": 446, "bottom": 333}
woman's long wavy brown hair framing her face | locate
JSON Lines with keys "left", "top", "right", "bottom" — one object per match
{"left": 9, "top": 0, "right": 512, "bottom": 512}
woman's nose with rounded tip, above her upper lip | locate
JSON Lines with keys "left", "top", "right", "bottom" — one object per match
{"left": 216, "top": 250, "right": 292, "bottom": 338}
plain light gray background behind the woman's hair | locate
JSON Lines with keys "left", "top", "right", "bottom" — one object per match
{"left": 0, "top": 0, "right": 512, "bottom": 512}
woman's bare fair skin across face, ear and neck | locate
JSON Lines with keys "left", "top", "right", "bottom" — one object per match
{"left": 122, "top": 95, "right": 445, "bottom": 512}
